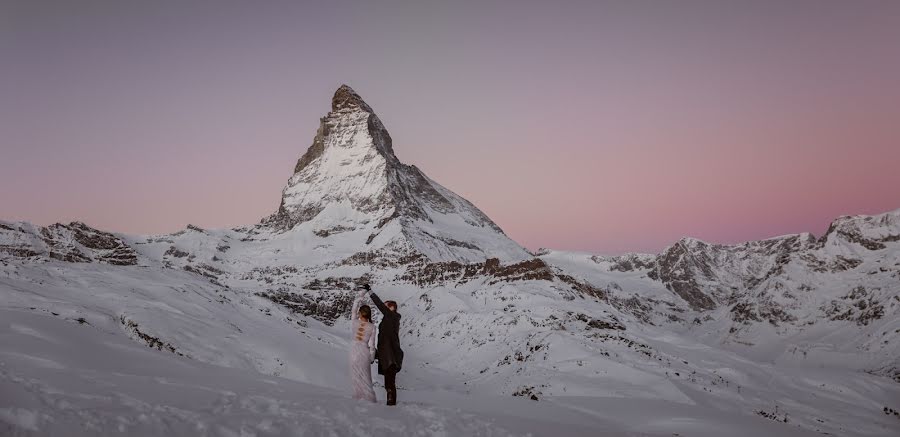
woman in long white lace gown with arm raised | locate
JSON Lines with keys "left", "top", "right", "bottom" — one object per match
{"left": 350, "top": 289, "right": 375, "bottom": 402}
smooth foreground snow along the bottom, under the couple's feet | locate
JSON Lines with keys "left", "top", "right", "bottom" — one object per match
{"left": 0, "top": 308, "right": 856, "bottom": 436}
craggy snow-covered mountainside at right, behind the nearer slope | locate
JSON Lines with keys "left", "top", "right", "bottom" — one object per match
{"left": 542, "top": 210, "right": 900, "bottom": 382}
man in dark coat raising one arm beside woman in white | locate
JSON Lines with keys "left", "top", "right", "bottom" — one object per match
{"left": 363, "top": 284, "right": 403, "bottom": 405}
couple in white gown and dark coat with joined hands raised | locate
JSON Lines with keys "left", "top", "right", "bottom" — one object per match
{"left": 350, "top": 284, "right": 403, "bottom": 405}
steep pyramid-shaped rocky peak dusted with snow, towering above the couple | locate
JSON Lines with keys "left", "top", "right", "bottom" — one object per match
{"left": 263, "top": 85, "right": 531, "bottom": 262}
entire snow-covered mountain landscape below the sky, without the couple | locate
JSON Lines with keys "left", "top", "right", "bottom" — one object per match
{"left": 0, "top": 86, "right": 900, "bottom": 436}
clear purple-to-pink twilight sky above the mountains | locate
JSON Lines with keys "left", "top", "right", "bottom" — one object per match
{"left": 0, "top": 0, "right": 900, "bottom": 253}
